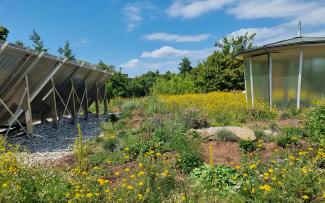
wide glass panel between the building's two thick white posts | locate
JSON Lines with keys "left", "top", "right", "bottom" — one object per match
{"left": 272, "top": 49, "right": 300, "bottom": 107}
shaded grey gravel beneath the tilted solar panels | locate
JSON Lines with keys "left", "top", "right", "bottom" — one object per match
{"left": 8, "top": 114, "right": 105, "bottom": 153}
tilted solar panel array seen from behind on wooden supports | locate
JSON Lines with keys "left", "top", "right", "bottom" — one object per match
{"left": 0, "top": 42, "right": 110, "bottom": 136}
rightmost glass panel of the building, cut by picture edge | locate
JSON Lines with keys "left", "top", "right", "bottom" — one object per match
{"left": 300, "top": 47, "right": 325, "bottom": 105}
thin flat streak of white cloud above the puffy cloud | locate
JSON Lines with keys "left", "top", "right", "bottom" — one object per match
{"left": 144, "top": 32, "right": 210, "bottom": 42}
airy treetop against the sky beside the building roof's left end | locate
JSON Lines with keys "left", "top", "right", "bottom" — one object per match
{"left": 214, "top": 32, "right": 256, "bottom": 56}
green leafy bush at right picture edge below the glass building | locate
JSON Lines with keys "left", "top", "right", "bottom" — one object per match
{"left": 305, "top": 104, "right": 325, "bottom": 145}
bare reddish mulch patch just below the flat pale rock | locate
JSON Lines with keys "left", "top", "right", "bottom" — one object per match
{"left": 202, "top": 141, "right": 240, "bottom": 166}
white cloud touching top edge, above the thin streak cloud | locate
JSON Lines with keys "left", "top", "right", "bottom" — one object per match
{"left": 167, "top": 0, "right": 234, "bottom": 18}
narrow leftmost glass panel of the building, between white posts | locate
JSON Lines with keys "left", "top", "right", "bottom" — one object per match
{"left": 252, "top": 55, "right": 269, "bottom": 103}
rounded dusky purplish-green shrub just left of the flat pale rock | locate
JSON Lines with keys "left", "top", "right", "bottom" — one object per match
{"left": 182, "top": 109, "right": 209, "bottom": 129}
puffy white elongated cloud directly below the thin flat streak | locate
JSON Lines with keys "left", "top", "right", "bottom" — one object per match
{"left": 141, "top": 46, "right": 213, "bottom": 59}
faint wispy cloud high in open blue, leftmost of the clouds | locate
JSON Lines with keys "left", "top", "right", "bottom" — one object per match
{"left": 123, "top": 2, "right": 154, "bottom": 32}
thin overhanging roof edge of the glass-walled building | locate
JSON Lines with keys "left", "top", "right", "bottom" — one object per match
{"left": 239, "top": 36, "right": 325, "bottom": 55}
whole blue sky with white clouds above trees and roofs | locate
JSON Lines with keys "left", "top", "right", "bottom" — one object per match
{"left": 0, "top": 0, "right": 325, "bottom": 76}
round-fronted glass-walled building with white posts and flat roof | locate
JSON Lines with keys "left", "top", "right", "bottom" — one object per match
{"left": 240, "top": 36, "right": 325, "bottom": 109}
